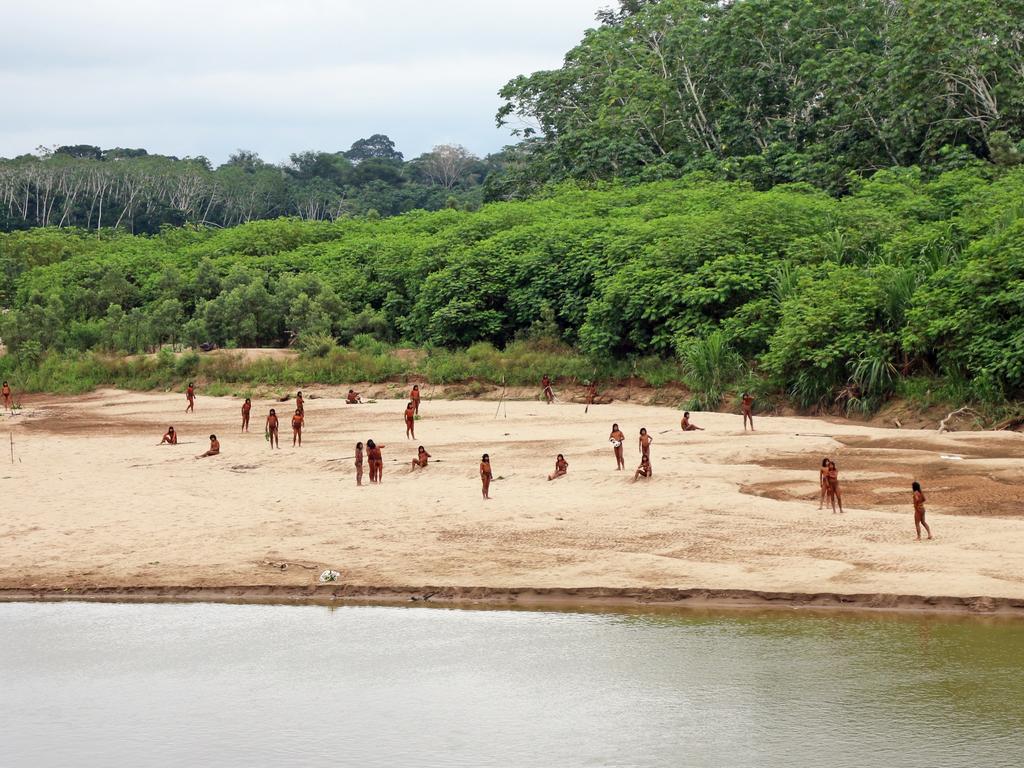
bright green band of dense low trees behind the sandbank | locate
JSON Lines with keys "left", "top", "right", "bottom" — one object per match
{"left": 0, "top": 167, "right": 1024, "bottom": 408}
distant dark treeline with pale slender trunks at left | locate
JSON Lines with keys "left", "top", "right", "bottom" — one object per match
{"left": 0, "top": 133, "right": 504, "bottom": 234}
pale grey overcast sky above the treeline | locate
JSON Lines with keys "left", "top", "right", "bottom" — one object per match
{"left": 0, "top": 0, "right": 616, "bottom": 164}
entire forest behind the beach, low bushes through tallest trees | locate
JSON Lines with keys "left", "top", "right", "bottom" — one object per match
{"left": 0, "top": 0, "right": 1024, "bottom": 411}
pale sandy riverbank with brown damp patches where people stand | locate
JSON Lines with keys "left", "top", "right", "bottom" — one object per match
{"left": 0, "top": 388, "right": 1024, "bottom": 610}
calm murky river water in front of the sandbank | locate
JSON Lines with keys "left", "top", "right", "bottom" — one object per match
{"left": 0, "top": 602, "right": 1024, "bottom": 768}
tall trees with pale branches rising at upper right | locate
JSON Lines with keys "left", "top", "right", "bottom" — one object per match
{"left": 488, "top": 0, "right": 1024, "bottom": 199}
